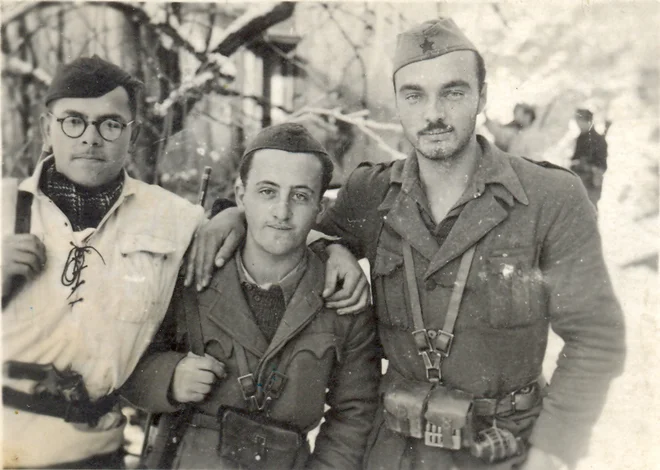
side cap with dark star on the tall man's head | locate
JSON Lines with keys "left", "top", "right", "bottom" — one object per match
{"left": 392, "top": 18, "right": 479, "bottom": 76}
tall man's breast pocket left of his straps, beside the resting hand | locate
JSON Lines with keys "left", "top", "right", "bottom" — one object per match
{"left": 372, "top": 245, "right": 409, "bottom": 329}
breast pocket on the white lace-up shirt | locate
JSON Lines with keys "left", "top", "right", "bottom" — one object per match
{"left": 116, "top": 233, "right": 176, "bottom": 323}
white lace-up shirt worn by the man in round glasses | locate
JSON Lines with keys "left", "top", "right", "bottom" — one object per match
{"left": 2, "top": 157, "right": 204, "bottom": 467}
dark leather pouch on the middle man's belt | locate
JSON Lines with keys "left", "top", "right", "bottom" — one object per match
{"left": 218, "top": 407, "right": 305, "bottom": 470}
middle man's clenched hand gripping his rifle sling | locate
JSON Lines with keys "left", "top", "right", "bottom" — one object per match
{"left": 172, "top": 352, "right": 227, "bottom": 403}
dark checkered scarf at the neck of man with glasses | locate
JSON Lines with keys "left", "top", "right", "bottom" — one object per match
{"left": 39, "top": 161, "right": 124, "bottom": 232}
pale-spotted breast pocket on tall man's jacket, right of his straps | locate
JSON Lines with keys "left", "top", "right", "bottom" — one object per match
{"left": 487, "top": 247, "right": 543, "bottom": 328}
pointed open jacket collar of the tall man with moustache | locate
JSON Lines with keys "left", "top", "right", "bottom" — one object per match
{"left": 390, "top": 135, "right": 529, "bottom": 222}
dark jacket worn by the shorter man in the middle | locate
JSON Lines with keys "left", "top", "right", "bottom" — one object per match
{"left": 123, "top": 251, "right": 380, "bottom": 469}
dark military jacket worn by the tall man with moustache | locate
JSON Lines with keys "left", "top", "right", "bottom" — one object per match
{"left": 320, "top": 136, "right": 624, "bottom": 468}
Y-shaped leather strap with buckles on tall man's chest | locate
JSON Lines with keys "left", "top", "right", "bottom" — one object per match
{"left": 402, "top": 240, "right": 476, "bottom": 383}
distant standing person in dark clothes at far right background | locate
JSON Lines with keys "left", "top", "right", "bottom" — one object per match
{"left": 571, "top": 109, "right": 607, "bottom": 206}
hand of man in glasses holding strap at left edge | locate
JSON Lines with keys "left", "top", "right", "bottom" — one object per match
{"left": 2, "top": 233, "right": 46, "bottom": 295}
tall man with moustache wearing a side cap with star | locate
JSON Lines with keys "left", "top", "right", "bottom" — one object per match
{"left": 199, "top": 18, "right": 625, "bottom": 470}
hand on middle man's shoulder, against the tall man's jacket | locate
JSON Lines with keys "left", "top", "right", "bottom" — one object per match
{"left": 323, "top": 244, "right": 371, "bottom": 315}
